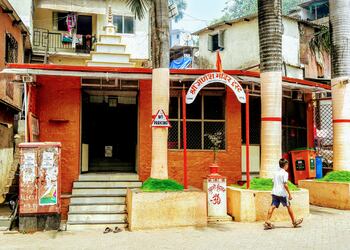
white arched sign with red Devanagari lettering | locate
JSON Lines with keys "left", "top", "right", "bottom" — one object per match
{"left": 186, "top": 72, "right": 246, "bottom": 104}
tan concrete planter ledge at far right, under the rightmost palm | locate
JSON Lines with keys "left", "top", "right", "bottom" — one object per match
{"left": 299, "top": 180, "right": 350, "bottom": 210}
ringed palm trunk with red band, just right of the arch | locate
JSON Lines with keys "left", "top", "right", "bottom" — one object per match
{"left": 258, "top": 0, "right": 282, "bottom": 178}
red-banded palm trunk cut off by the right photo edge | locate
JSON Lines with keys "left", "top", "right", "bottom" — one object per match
{"left": 329, "top": 0, "right": 350, "bottom": 170}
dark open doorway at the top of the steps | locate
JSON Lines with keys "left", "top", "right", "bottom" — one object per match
{"left": 82, "top": 90, "right": 137, "bottom": 172}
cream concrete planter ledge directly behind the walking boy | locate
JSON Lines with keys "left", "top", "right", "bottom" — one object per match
{"left": 227, "top": 187, "right": 310, "bottom": 222}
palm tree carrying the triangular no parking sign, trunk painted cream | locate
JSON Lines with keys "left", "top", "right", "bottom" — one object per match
{"left": 126, "top": 0, "right": 169, "bottom": 179}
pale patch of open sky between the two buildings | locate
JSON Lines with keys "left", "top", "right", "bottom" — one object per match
{"left": 173, "top": 0, "right": 226, "bottom": 32}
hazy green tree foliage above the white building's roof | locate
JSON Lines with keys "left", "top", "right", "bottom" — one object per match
{"left": 213, "top": 0, "right": 306, "bottom": 23}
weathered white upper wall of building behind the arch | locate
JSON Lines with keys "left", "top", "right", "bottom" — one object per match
{"left": 199, "top": 18, "right": 303, "bottom": 78}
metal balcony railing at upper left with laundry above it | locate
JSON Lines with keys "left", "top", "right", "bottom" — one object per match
{"left": 33, "top": 28, "right": 96, "bottom": 54}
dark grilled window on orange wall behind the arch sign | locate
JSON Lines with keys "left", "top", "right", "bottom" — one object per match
{"left": 168, "top": 91, "right": 226, "bottom": 150}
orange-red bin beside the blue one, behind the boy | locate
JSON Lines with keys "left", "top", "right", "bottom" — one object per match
{"left": 290, "top": 149, "right": 316, "bottom": 184}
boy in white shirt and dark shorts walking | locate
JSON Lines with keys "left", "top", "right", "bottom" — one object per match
{"left": 264, "top": 159, "right": 303, "bottom": 229}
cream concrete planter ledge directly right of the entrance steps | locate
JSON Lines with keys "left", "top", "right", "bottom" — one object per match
{"left": 126, "top": 189, "right": 207, "bottom": 231}
